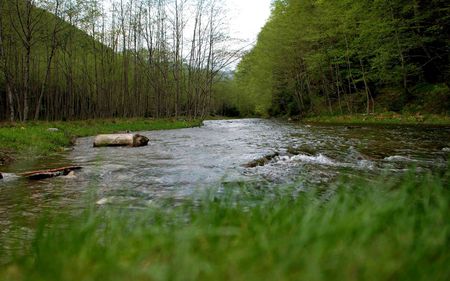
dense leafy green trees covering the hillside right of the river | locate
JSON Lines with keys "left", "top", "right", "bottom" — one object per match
{"left": 230, "top": 0, "right": 450, "bottom": 115}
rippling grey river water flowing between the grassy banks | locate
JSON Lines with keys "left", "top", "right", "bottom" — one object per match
{"left": 0, "top": 119, "right": 450, "bottom": 256}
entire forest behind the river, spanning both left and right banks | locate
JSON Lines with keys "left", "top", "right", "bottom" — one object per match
{"left": 0, "top": 0, "right": 450, "bottom": 121}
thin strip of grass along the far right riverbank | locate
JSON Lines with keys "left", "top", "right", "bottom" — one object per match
{"left": 302, "top": 112, "right": 450, "bottom": 126}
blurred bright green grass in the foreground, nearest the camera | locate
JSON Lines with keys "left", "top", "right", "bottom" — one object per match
{"left": 0, "top": 171, "right": 450, "bottom": 280}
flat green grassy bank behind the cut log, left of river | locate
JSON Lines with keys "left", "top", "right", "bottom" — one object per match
{"left": 0, "top": 119, "right": 201, "bottom": 160}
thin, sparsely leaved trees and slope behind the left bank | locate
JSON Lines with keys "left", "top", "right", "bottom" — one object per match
{"left": 0, "top": 0, "right": 236, "bottom": 121}
